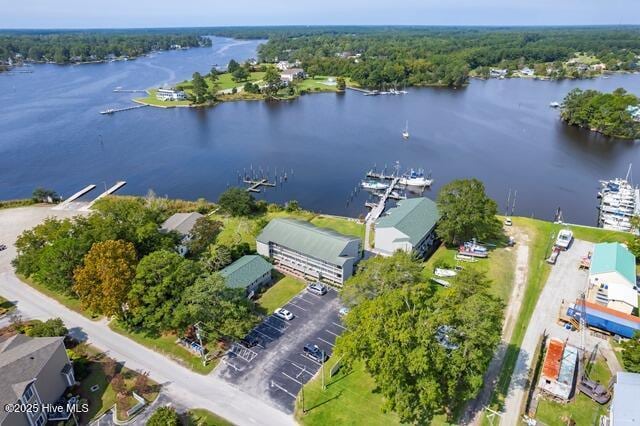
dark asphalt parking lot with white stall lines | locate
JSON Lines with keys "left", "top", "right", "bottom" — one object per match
{"left": 214, "top": 288, "right": 344, "bottom": 413}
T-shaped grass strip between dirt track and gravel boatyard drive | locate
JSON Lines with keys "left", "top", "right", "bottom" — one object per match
{"left": 483, "top": 217, "right": 630, "bottom": 424}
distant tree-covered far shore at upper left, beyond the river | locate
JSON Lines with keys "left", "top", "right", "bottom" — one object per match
{"left": 0, "top": 29, "right": 211, "bottom": 64}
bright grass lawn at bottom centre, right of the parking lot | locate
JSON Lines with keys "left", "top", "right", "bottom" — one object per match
{"left": 295, "top": 362, "right": 400, "bottom": 426}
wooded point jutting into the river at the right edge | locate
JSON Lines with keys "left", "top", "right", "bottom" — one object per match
{"left": 561, "top": 88, "right": 640, "bottom": 139}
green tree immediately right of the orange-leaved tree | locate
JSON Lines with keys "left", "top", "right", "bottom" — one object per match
{"left": 126, "top": 250, "right": 202, "bottom": 334}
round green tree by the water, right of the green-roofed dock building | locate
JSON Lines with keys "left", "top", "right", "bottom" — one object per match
{"left": 436, "top": 179, "right": 501, "bottom": 244}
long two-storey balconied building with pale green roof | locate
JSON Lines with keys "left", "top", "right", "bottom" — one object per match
{"left": 256, "top": 219, "right": 361, "bottom": 286}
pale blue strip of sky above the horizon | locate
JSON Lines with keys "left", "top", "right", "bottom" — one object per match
{"left": 0, "top": 0, "right": 640, "bottom": 29}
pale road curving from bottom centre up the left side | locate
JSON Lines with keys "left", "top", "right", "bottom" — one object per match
{"left": 0, "top": 207, "right": 295, "bottom": 425}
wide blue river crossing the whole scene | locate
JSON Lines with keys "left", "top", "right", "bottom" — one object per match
{"left": 0, "top": 38, "right": 640, "bottom": 225}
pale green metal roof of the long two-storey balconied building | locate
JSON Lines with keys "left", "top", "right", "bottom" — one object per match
{"left": 256, "top": 219, "right": 360, "bottom": 266}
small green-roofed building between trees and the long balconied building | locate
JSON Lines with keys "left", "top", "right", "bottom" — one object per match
{"left": 220, "top": 255, "right": 273, "bottom": 299}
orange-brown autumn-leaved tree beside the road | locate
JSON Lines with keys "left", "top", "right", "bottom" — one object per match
{"left": 73, "top": 240, "right": 137, "bottom": 317}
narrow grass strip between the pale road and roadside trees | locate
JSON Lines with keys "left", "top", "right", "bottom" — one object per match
{"left": 109, "top": 321, "right": 218, "bottom": 374}
